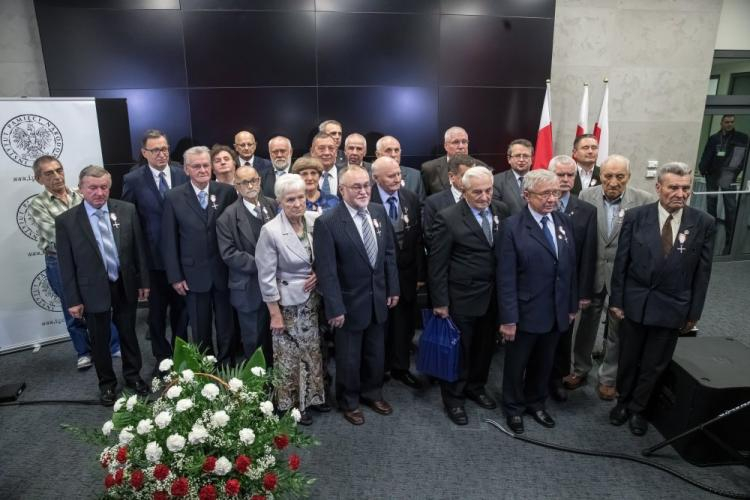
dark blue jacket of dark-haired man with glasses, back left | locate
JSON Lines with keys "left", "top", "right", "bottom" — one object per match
{"left": 122, "top": 164, "right": 188, "bottom": 271}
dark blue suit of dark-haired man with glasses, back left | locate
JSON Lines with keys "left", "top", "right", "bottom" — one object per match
{"left": 122, "top": 163, "right": 188, "bottom": 364}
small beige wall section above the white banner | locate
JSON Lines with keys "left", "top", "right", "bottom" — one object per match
{"left": 0, "top": 0, "right": 49, "bottom": 97}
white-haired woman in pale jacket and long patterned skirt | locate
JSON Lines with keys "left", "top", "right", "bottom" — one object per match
{"left": 255, "top": 174, "right": 325, "bottom": 425}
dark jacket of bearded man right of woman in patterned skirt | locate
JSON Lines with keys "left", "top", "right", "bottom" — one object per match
{"left": 313, "top": 202, "right": 400, "bottom": 330}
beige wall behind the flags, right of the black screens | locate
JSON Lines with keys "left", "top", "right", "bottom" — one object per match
{"left": 551, "top": 0, "right": 722, "bottom": 190}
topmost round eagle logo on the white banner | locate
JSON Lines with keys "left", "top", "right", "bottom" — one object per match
{"left": 2, "top": 114, "right": 63, "bottom": 167}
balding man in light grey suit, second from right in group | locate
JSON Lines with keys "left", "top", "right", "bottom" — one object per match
{"left": 563, "top": 155, "right": 654, "bottom": 401}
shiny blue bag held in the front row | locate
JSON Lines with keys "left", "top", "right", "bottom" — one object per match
{"left": 417, "top": 309, "right": 461, "bottom": 382}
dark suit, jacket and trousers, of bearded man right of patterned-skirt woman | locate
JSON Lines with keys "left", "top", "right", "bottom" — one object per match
{"left": 313, "top": 203, "right": 399, "bottom": 411}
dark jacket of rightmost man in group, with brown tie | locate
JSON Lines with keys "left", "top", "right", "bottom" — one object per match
{"left": 609, "top": 202, "right": 716, "bottom": 329}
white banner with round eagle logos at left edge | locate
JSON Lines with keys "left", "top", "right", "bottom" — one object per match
{"left": 0, "top": 98, "right": 102, "bottom": 352}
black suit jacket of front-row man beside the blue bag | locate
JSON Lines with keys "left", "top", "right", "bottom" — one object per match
{"left": 427, "top": 200, "right": 509, "bottom": 316}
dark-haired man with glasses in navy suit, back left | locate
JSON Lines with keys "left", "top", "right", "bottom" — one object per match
{"left": 122, "top": 130, "right": 188, "bottom": 368}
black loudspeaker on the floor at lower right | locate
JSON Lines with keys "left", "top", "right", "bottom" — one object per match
{"left": 649, "top": 337, "right": 750, "bottom": 466}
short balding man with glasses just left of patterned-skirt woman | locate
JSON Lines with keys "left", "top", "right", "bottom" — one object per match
{"left": 216, "top": 167, "right": 278, "bottom": 360}
